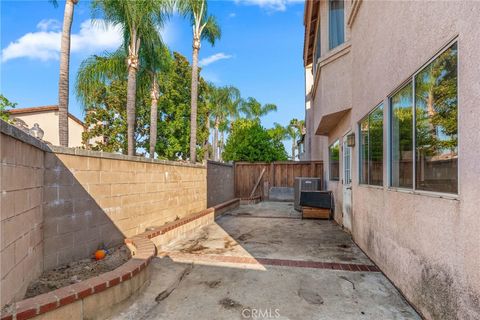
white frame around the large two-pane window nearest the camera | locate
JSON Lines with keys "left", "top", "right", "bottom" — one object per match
{"left": 384, "top": 36, "right": 461, "bottom": 199}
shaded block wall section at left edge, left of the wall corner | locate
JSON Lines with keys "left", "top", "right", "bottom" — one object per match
{"left": 0, "top": 131, "right": 44, "bottom": 306}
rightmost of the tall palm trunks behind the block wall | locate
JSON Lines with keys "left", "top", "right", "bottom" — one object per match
{"left": 190, "top": 35, "right": 200, "bottom": 163}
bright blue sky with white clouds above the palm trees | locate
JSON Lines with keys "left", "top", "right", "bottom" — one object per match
{"left": 0, "top": 0, "right": 304, "bottom": 150}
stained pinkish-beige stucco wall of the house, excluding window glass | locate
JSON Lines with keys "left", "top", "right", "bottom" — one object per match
{"left": 307, "top": 1, "right": 480, "bottom": 319}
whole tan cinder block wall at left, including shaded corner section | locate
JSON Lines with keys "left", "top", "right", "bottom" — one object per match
{"left": 0, "top": 120, "right": 207, "bottom": 307}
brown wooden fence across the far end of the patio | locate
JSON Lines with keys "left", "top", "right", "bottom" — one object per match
{"left": 234, "top": 161, "right": 324, "bottom": 200}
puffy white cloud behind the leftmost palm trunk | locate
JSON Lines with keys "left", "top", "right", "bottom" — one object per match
{"left": 2, "top": 19, "right": 122, "bottom": 62}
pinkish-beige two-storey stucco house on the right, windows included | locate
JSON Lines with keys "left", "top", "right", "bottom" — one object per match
{"left": 303, "top": 0, "right": 480, "bottom": 319}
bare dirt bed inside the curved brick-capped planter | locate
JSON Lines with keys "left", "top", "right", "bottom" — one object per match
{"left": 25, "top": 245, "right": 131, "bottom": 299}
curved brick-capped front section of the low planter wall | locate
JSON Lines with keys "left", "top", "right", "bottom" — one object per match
{"left": 1, "top": 237, "right": 156, "bottom": 320}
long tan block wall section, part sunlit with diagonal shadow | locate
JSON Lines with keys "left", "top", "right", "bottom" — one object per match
{"left": 43, "top": 147, "right": 207, "bottom": 269}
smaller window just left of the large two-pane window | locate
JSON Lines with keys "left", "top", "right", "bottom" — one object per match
{"left": 358, "top": 104, "right": 383, "bottom": 186}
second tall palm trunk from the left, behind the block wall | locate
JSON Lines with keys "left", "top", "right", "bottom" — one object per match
{"left": 127, "top": 29, "right": 140, "bottom": 156}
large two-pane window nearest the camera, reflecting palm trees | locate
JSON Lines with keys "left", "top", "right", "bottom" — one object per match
{"left": 389, "top": 42, "right": 458, "bottom": 194}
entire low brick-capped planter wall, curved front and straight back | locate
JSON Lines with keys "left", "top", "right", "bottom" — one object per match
{"left": 1, "top": 199, "right": 240, "bottom": 320}
